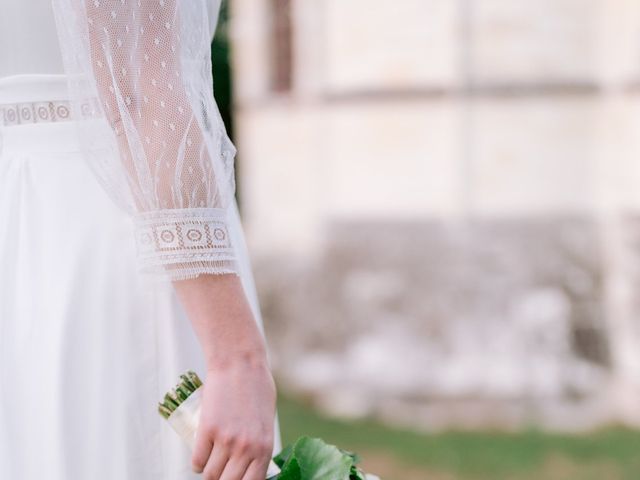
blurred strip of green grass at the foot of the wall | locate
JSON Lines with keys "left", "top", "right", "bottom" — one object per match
{"left": 278, "top": 396, "right": 640, "bottom": 480}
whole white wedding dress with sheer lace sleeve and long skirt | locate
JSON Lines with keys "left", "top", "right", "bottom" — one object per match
{"left": 0, "top": 0, "right": 281, "bottom": 480}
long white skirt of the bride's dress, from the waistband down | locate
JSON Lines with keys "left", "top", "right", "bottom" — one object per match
{"left": 0, "top": 76, "right": 281, "bottom": 480}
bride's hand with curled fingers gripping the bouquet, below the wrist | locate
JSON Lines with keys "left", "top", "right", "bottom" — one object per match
{"left": 192, "top": 353, "right": 276, "bottom": 480}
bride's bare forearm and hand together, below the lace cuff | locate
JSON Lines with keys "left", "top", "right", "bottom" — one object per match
{"left": 174, "top": 274, "right": 276, "bottom": 480}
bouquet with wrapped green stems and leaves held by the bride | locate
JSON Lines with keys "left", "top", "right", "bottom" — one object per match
{"left": 158, "top": 370, "right": 380, "bottom": 480}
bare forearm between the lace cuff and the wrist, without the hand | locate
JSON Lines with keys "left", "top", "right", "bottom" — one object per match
{"left": 174, "top": 275, "right": 266, "bottom": 369}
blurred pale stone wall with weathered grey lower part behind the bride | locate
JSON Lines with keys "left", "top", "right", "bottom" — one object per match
{"left": 231, "top": 0, "right": 640, "bottom": 430}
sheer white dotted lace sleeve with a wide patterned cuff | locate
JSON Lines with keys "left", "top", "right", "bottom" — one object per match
{"left": 53, "top": 0, "right": 238, "bottom": 280}
